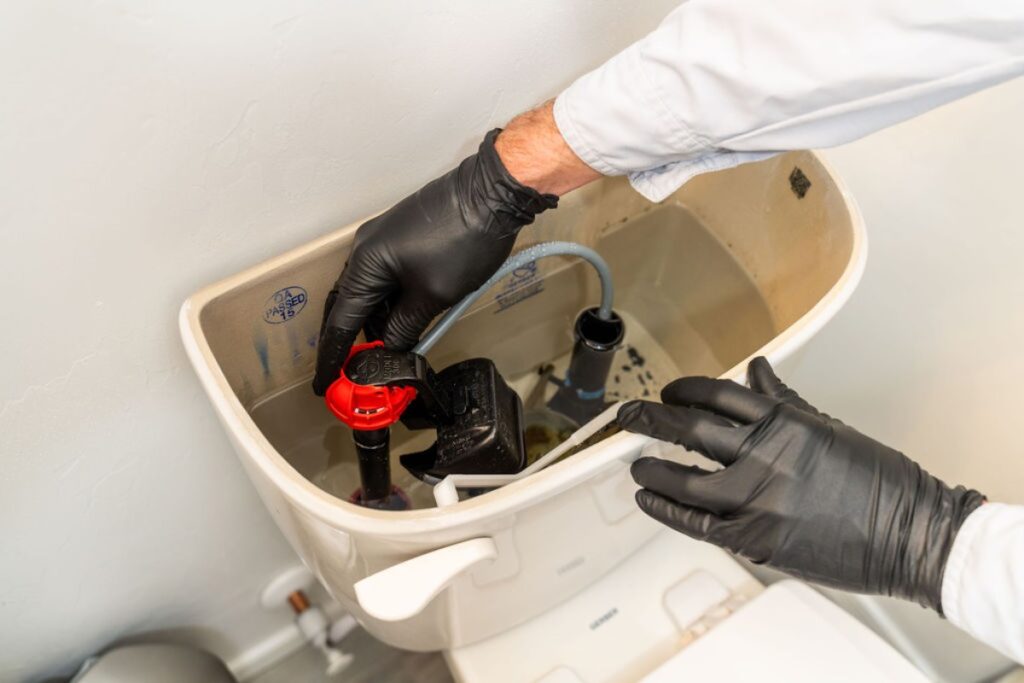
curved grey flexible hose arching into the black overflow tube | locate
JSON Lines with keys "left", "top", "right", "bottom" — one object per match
{"left": 413, "top": 242, "right": 614, "bottom": 355}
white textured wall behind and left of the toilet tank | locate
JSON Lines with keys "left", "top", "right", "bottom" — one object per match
{"left": 0, "top": 0, "right": 676, "bottom": 681}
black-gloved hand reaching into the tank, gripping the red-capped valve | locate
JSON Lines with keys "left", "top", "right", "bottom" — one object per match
{"left": 313, "top": 130, "right": 558, "bottom": 395}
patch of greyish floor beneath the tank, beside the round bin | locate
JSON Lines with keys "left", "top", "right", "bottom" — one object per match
{"left": 250, "top": 629, "right": 454, "bottom": 683}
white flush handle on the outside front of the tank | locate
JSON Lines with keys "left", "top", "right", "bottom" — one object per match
{"left": 355, "top": 538, "right": 498, "bottom": 622}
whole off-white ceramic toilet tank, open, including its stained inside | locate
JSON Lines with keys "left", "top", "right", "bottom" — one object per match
{"left": 180, "top": 153, "right": 866, "bottom": 650}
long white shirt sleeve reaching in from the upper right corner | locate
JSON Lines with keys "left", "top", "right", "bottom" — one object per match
{"left": 555, "top": 0, "right": 1024, "bottom": 201}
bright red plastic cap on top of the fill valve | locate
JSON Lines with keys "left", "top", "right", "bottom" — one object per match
{"left": 324, "top": 341, "right": 416, "bottom": 431}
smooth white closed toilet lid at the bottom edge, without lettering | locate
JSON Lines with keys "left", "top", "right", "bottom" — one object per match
{"left": 643, "top": 581, "right": 928, "bottom": 683}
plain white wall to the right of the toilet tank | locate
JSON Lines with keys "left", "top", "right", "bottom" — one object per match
{"left": 786, "top": 79, "right": 1024, "bottom": 682}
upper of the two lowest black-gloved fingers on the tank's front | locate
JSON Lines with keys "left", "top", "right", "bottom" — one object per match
{"left": 630, "top": 458, "right": 748, "bottom": 515}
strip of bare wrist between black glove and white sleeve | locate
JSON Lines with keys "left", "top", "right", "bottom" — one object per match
{"left": 495, "top": 100, "right": 601, "bottom": 197}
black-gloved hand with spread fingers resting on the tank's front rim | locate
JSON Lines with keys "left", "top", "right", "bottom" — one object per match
{"left": 618, "top": 358, "right": 984, "bottom": 613}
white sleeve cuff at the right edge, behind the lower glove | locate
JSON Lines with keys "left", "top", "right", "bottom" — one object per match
{"left": 942, "top": 503, "right": 1024, "bottom": 664}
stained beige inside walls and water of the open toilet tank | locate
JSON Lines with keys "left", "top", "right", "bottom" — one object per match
{"left": 200, "top": 153, "right": 853, "bottom": 503}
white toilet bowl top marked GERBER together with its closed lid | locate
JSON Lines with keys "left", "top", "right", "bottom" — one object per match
{"left": 445, "top": 529, "right": 927, "bottom": 683}
